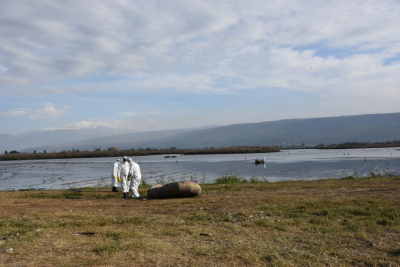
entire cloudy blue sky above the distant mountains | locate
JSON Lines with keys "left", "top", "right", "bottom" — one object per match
{"left": 0, "top": 0, "right": 400, "bottom": 134}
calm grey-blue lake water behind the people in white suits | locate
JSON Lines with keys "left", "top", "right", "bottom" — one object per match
{"left": 0, "top": 148, "right": 400, "bottom": 191}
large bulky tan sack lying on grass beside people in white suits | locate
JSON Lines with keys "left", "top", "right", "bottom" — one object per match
{"left": 147, "top": 181, "right": 201, "bottom": 198}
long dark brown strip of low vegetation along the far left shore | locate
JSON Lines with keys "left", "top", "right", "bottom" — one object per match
{"left": 0, "top": 147, "right": 279, "bottom": 161}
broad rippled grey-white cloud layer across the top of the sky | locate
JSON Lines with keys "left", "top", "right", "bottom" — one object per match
{"left": 0, "top": 0, "right": 400, "bottom": 91}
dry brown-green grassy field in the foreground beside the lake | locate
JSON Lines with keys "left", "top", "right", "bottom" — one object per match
{"left": 0, "top": 177, "right": 400, "bottom": 266}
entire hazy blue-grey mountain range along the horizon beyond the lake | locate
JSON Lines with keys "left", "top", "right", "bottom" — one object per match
{"left": 0, "top": 113, "right": 400, "bottom": 155}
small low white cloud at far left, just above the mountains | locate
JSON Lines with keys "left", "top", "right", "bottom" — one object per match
{"left": 0, "top": 102, "right": 70, "bottom": 121}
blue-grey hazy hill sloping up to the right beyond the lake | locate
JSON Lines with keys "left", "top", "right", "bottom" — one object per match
{"left": 167, "top": 113, "right": 400, "bottom": 148}
